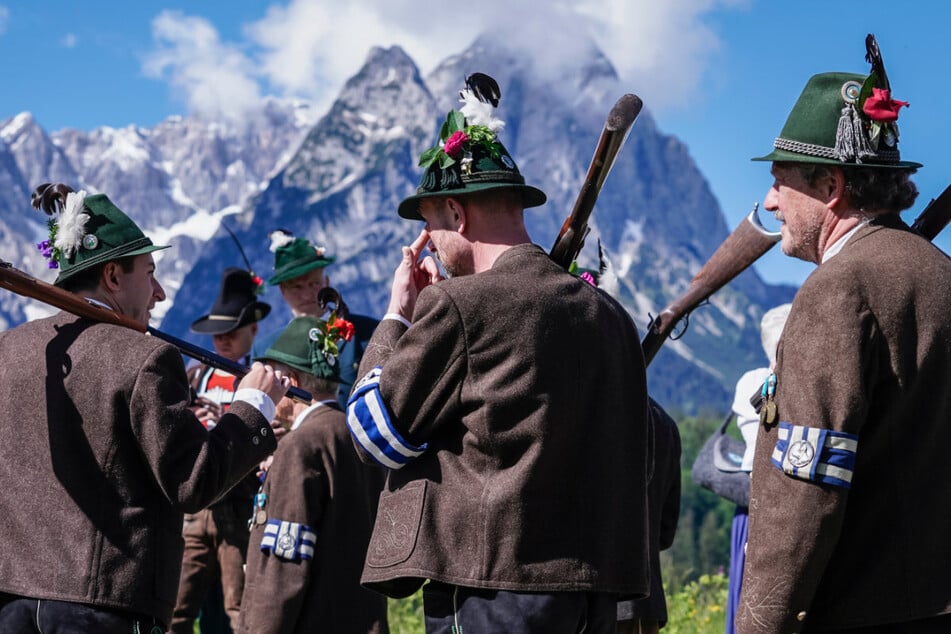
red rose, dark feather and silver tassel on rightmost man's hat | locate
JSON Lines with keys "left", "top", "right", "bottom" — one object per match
{"left": 835, "top": 33, "right": 908, "bottom": 163}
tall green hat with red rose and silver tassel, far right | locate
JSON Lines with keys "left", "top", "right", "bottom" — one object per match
{"left": 753, "top": 33, "right": 921, "bottom": 168}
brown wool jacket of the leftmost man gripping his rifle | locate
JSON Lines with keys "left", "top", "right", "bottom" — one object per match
{"left": 0, "top": 313, "right": 276, "bottom": 623}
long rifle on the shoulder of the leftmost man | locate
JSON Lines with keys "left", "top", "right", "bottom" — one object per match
{"left": 0, "top": 259, "right": 311, "bottom": 403}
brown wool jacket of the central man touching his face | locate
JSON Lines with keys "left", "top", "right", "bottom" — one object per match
{"left": 348, "top": 244, "right": 649, "bottom": 597}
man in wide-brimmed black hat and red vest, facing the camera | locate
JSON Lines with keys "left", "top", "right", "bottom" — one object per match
{"left": 170, "top": 267, "right": 276, "bottom": 634}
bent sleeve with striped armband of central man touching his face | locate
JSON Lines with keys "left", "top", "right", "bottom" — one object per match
{"left": 347, "top": 286, "right": 468, "bottom": 469}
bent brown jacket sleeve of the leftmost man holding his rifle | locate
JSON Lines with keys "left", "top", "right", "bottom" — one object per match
{"left": 129, "top": 345, "right": 277, "bottom": 513}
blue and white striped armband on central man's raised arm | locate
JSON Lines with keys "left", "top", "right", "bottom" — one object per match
{"left": 347, "top": 367, "right": 426, "bottom": 469}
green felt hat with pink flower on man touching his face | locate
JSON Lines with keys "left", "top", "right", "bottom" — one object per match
{"left": 397, "top": 110, "right": 546, "bottom": 220}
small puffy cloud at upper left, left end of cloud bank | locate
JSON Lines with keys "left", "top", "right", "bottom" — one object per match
{"left": 143, "top": 11, "right": 261, "bottom": 118}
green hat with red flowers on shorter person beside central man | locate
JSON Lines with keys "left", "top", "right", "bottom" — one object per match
{"left": 255, "top": 314, "right": 353, "bottom": 383}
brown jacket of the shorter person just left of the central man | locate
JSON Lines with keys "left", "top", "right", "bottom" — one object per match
{"left": 241, "top": 402, "right": 389, "bottom": 634}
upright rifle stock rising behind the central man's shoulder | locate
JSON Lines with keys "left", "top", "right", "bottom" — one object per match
{"left": 549, "top": 93, "right": 644, "bottom": 269}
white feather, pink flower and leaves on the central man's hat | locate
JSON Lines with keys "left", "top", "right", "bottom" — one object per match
{"left": 419, "top": 73, "right": 505, "bottom": 174}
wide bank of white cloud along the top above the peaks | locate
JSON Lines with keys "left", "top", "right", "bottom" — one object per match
{"left": 148, "top": 0, "right": 751, "bottom": 118}
